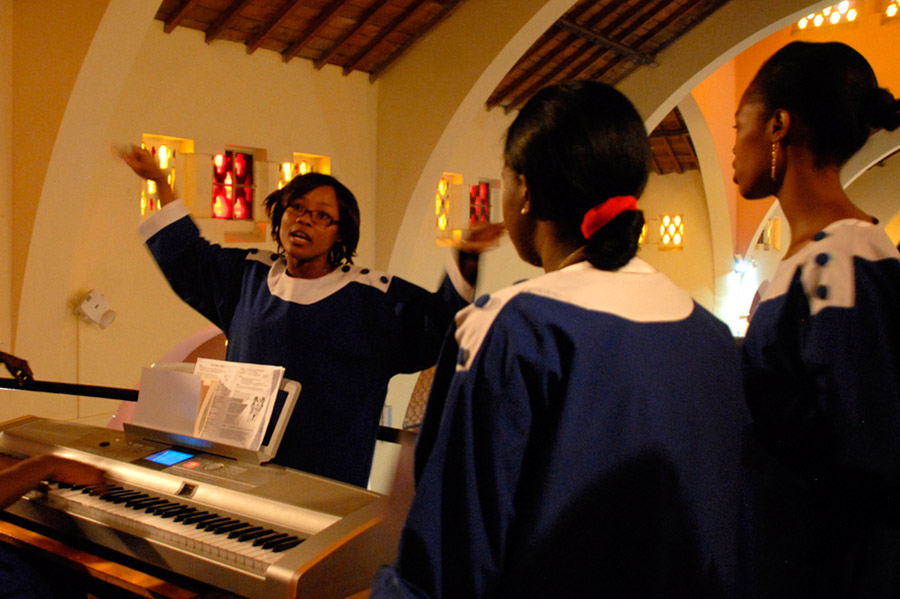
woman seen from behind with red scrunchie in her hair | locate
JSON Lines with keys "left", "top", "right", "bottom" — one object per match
{"left": 371, "top": 81, "right": 746, "bottom": 599}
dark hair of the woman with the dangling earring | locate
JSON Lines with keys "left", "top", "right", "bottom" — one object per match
{"left": 745, "top": 42, "right": 900, "bottom": 167}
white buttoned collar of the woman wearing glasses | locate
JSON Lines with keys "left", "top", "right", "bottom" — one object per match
{"left": 268, "top": 257, "right": 392, "bottom": 305}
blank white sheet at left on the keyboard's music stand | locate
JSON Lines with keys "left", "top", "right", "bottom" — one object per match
{"left": 134, "top": 368, "right": 200, "bottom": 436}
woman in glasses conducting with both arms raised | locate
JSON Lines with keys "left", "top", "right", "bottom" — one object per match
{"left": 123, "top": 148, "right": 502, "bottom": 486}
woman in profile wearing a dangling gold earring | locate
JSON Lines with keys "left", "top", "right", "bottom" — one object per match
{"left": 734, "top": 42, "right": 900, "bottom": 597}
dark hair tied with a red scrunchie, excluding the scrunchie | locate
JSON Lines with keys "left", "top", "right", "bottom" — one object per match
{"left": 504, "top": 80, "right": 650, "bottom": 270}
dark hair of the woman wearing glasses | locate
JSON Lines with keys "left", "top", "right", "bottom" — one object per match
{"left": 265, "top": 173, "right": 359, "bottom": 267}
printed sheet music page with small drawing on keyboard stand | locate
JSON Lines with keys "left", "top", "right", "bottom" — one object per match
{"left": 194, "top": 358, "right": 284, "bottom": 451}
